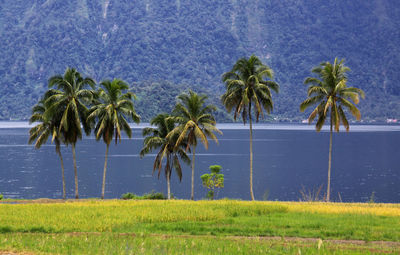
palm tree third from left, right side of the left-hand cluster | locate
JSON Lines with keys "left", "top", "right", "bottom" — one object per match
{"left": 88, "top": 79, "right": 140, "bottom": 199}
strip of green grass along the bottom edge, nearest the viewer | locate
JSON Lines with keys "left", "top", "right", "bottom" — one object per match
{"left": 0, "top": 233, "right": 399, "bottom": 254}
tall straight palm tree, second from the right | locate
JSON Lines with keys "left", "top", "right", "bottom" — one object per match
{"left": 221, "top": 55, "right": 279, "bottom": 200}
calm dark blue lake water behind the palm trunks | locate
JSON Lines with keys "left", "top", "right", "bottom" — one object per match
{"left": 0, "top": 122, "right": 400, "bottom": 203}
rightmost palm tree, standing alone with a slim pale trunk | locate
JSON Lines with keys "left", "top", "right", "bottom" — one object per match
{"left": 300, "top": 58, "right": 365, "bottom": 202}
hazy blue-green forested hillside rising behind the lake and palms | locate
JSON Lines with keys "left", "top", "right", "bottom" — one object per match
{"left": 0, "top": 0, "right": 400, "bottom": 121}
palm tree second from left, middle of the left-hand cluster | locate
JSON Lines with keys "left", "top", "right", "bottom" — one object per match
{"left": 44, "top": 68, "right": 95, "bottom": 199}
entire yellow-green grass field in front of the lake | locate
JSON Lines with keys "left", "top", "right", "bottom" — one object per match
{"left": 0, "top": 200, "right": 400, "bottom": 254}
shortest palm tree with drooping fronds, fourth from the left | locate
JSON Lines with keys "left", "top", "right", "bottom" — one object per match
{"left": 140, "top": 114, "right": 190, "bottom": 199}
